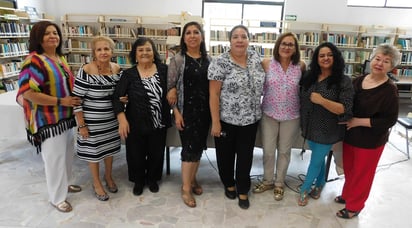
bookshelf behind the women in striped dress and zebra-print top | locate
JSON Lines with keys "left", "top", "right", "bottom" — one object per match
{"left": 61, "top": 13, "right": 202, "bottom": 72}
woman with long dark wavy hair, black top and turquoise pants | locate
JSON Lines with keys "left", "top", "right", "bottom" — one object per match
{"left": 298, "top": 42, "right": 354, "bottom": 206}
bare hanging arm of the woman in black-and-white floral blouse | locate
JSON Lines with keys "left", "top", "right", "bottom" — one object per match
{"left": 209, "top": 80, "right": 222, "bottom": 137}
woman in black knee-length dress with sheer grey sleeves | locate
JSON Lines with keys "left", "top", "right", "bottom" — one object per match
{"left": 167, "top": 22, "right": 210, "bottom": 207}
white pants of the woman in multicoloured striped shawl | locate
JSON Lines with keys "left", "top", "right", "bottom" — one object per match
{"left": 40, "top": 129, "right": 74, "bottom": 205}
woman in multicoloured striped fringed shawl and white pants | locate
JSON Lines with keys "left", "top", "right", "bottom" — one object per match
{"left": 17, "top": 21, "right": 81, "bottom": 212}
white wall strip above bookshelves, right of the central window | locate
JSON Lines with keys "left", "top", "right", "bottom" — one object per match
{"left": 285, "top": 0, "right": 412, "bottom": 27}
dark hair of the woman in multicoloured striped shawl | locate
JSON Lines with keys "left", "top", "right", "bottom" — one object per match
{"left": 29, "top": 21, "right": 63, "bottom": 56}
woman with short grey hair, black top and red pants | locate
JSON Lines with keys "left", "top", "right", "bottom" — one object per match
{"left": 335, "top": 44, "right": 400, "bottom": 218}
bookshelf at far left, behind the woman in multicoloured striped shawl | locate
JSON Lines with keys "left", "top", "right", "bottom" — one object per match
{"left": 0, "top": 7, "right": 31, "bottom": 91}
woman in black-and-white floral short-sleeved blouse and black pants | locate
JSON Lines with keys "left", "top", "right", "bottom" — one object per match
{"left": 208, "top": 25, "right": 265, "bottom": 209}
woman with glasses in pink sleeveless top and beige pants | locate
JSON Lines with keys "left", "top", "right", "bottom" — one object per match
{"left": 253, "top": 33, "right": 306, "bottom": 200}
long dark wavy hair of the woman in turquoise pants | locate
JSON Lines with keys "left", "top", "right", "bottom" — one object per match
{"left": 300, "top": 42, "right": 345, "bottom": 90}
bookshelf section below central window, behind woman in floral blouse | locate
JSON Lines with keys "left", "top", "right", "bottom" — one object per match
{"left": 206, "top": 18, "right": 281, "bottom": 58}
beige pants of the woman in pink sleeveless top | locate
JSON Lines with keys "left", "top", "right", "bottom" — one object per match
{"left": 260, "top": 114, "right": 300, "bottom": 187}
